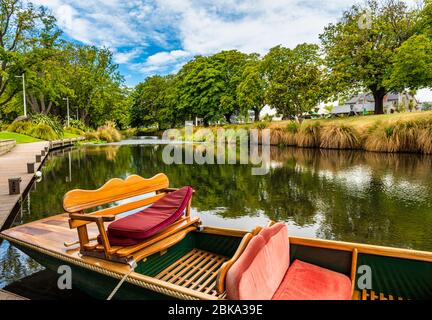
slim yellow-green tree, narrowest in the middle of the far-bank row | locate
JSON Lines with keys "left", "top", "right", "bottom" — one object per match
{"left": 237, "top": 59, "right": 268, "bottom": 121}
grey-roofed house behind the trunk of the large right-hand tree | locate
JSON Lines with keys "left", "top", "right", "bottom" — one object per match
{"left": 331, "top": 92, "right": 419, "bottom": 115}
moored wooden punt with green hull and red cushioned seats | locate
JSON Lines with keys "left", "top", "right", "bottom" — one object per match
{"left": 0, "top": 174, "right": 432, "bottom": 300}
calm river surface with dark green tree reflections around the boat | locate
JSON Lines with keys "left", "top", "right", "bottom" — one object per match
{"left": 0, "top": 145, "right": 432, "bottom": 298}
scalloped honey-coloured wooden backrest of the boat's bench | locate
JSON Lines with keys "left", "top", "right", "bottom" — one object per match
{"left": 63, "top": 173, "right": 169, "bottom": 213}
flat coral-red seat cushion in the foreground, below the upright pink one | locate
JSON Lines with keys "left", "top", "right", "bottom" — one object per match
{"left": 272, "top": 260, "right": 352, "bottom": 300}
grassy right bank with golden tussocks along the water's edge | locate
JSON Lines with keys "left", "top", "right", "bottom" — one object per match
{"left": 171, "top": 111, "right": 432, "bottom": 154}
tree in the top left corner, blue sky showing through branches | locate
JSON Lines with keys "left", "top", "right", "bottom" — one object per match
{"left": 0, "top": 0, "right": 61, "bottom": 106}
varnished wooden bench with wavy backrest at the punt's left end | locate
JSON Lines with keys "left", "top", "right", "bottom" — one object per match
{"left": 63, "top": 174, "right": 201, "bottom": 263}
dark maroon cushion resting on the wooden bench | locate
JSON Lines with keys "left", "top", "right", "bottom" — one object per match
{"left": 100, "top": 187, "right": 193, "bottom": 246}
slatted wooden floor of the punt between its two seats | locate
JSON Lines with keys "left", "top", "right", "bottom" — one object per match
{"left": 156, "top": 249, "right": 229, "bottom": 298}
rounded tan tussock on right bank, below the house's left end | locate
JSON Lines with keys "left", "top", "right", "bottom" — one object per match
{"left": 320, "top": 124, "right": 361, "bottom": 149}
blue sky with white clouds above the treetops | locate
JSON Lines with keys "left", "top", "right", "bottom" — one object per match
{"left": 32, "top": 0, "right": 432, "bottom": 101}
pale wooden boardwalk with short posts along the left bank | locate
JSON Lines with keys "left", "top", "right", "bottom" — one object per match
{"left": 0, "top": 141, "right": 49, "bottom": 230}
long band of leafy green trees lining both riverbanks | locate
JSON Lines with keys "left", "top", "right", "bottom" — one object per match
{"left": 0, "top": 0, "right": 432, "bottom": 129}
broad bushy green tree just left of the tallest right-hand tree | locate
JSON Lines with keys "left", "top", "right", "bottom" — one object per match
{"left": 264, "top": 44, "right": 325, "bottom": 119}
